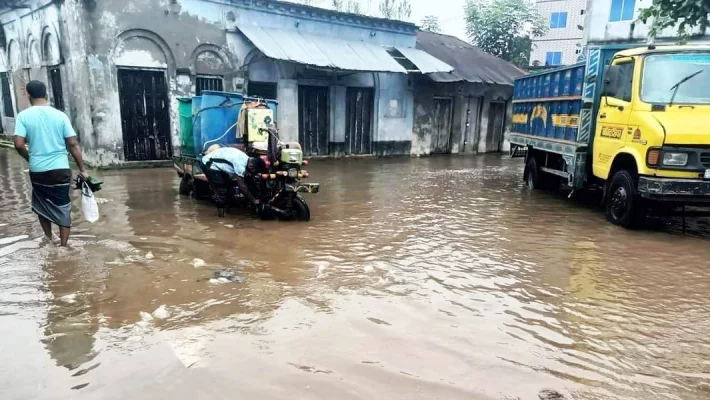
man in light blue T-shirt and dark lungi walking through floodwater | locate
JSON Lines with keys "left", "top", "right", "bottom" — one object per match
{"left": 14, "top": 81, "right": 89, "bottom": 246}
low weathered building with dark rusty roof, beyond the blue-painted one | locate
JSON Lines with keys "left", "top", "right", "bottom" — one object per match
{"left": 412, "top": 32, "right": 523, "bottom": 155}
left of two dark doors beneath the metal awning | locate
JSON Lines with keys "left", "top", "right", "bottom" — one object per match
{"left": 298, "top": 86, "right": 330, "bottom": 156}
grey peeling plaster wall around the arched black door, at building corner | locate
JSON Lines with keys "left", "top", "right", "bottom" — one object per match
{"left": 77, "top": 0, "right": 235, "bottom": 165}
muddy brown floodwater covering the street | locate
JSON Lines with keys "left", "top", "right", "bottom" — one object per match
{"left": 0, "top": 149, "right": 710, "bottom": 399}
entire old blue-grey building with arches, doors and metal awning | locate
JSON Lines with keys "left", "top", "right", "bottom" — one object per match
{"left": 0, "top": 0, "right": 524, "bottom": 166}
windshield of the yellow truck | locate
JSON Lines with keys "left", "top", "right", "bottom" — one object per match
{"left": 641, "top": 53, "right": 710, "bottom": 104}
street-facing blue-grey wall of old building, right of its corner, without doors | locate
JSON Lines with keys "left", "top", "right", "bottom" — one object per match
{"left": 76, "top": 0, "right": 415, "bottom": 165}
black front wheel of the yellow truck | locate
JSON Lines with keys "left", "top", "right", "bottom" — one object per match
{"left": 605, "top": 170, "right": 645, "bottom": 229}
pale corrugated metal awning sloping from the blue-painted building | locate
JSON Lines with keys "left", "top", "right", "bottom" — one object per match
{"left": 239, "top": 25, "right": 453, "bottom": 74}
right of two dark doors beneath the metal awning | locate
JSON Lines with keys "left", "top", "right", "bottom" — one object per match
{"left": 344, "top": 88, "right": 375, "bottom": 154}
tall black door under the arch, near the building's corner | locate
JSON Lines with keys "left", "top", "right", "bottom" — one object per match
{"left": 118, "top": 69, "right": 173, "bottom": 161}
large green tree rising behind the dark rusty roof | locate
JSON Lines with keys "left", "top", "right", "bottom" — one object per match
{"left": 465, "top": 0, "right": 548, "bottom": 67}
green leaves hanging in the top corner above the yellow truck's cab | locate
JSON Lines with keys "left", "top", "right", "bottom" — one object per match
{"left": 639, "top": 0, "right": 710, "bottom": 38}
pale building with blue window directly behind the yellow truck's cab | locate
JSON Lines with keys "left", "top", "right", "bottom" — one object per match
{"left": 584, "top": 0, "right": 710, "bottom": 44}
